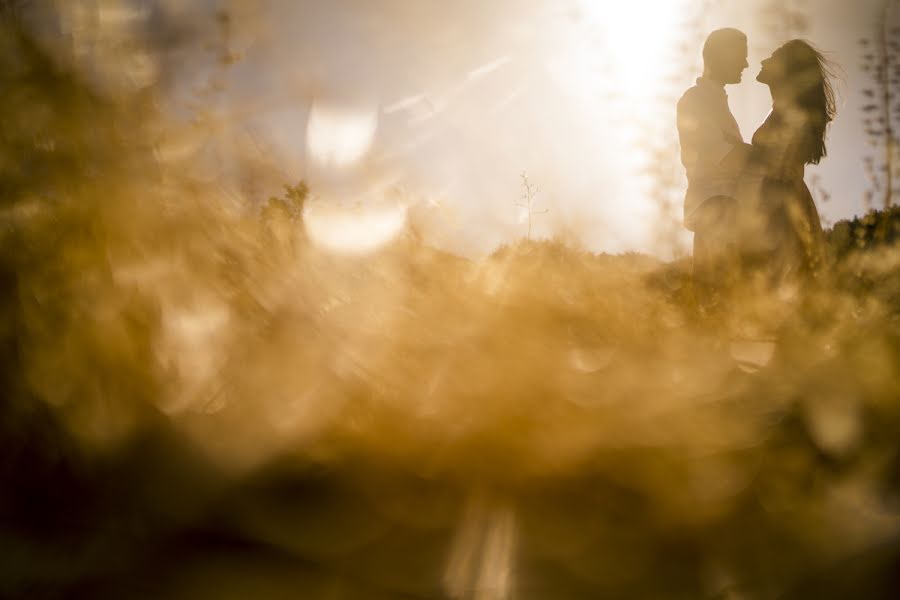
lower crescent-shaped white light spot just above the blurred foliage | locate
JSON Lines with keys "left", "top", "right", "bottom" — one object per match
{"left": 303, "top": 202, "right": 406, "bottom": 254}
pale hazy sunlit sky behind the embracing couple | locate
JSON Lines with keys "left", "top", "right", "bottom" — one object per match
{"left": 144, "top": 0, "right": 900, "bottom": 256}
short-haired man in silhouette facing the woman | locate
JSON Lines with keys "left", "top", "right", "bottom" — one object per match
{"left": 678, "top": 29, "right": 748, "bottom": 308}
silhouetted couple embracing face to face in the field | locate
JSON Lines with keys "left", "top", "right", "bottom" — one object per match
{"left": 678, "top": 29, "right": 835, "bottom": 306}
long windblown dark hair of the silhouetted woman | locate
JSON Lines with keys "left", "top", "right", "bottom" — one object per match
{"left": 776, "top": 40, "right": 837, "bottom": 164}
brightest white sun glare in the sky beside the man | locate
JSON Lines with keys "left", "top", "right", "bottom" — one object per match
{"left": 545, "top": 0, "right": 691, "bottom": 247}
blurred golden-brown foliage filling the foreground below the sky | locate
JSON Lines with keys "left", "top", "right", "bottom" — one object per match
{"left": 0, "top": 4, "right": 900, "bottom": 598}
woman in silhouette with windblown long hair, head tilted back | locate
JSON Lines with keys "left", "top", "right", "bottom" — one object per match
{"left": 738, "top": 40, "right": 835, "bottom": 283}
